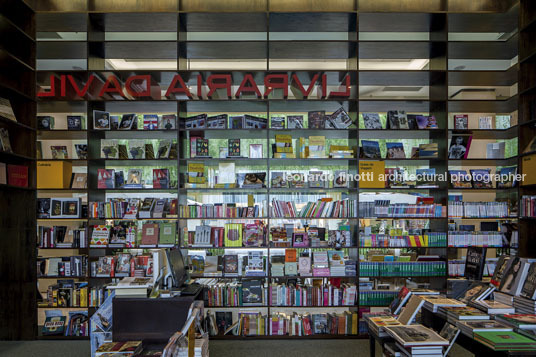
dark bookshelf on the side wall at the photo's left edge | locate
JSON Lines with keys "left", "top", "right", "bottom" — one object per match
{"left": 0, "top": 0, "right": 36, "bottom": 340}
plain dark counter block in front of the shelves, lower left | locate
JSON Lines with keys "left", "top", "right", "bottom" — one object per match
{"left": 112, "top": 294, "right": 200, "bottom": 343}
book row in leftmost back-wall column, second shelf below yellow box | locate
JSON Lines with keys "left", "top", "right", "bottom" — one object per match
{"left": 37, "top": 226, "right": 87, "bottom": 248}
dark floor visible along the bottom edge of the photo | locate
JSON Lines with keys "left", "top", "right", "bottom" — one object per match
{"left": 0, "top": 340, "right": 472, "bottom": 357}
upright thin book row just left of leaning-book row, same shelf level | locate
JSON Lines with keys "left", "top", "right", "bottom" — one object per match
{"left": 179, "top": 203, "right": 264, "bottom": 218}
